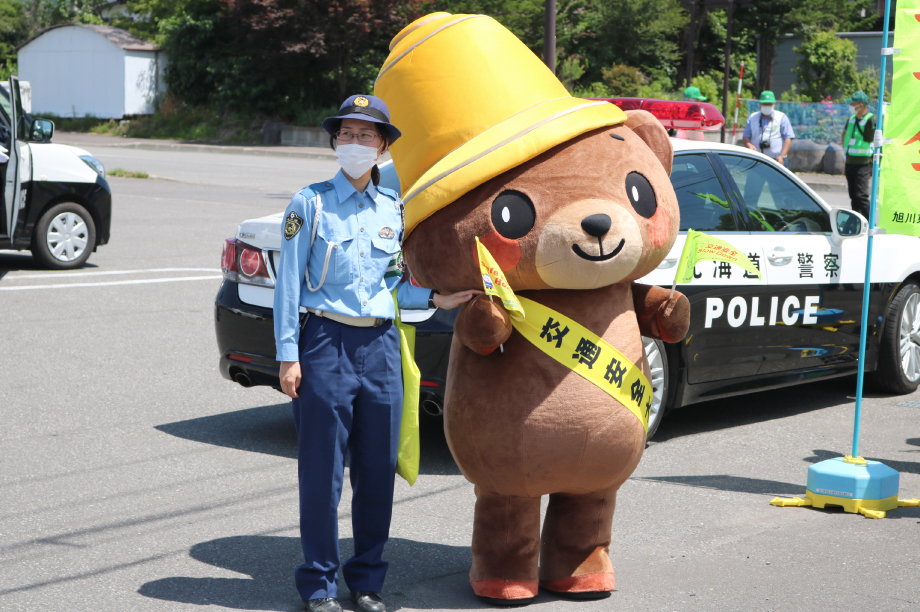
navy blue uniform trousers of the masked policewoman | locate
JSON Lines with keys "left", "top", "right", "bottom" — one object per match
{"left": 293, "top": 316, "right": 403, "bottom": 601}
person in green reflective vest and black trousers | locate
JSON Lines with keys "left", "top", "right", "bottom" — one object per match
{"left": 843, "top": 91, "right": 875, "bottom": 219}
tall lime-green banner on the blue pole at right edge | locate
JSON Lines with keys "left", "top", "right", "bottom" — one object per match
{"left": 878, "top": 0, "right": 920, "bottom": 236}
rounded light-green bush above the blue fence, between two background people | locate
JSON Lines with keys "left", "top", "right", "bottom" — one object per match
{"left": 793, "top": 32, "right": 856, "bottom": 102}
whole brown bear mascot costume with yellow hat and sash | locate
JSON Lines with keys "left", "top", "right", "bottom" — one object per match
{"left": 375, "top": 13, "right": 690, "bottom": 605}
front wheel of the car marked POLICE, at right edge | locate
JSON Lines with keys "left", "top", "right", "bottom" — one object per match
{"left": 867, "top": 283, "right": 920, "bottom": 395}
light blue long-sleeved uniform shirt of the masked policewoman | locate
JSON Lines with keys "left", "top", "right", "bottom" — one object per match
{"left": 274, "top": 170, "right": 431, "bottom": 361}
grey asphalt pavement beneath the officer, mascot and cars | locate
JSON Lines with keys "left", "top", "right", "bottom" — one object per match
{"left": 0, "top": 138, "right": 920, "bottom": 612}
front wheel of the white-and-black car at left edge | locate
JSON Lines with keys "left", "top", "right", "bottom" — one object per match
{"left": 32, "top": 202, "right": 96, "bottom": 270}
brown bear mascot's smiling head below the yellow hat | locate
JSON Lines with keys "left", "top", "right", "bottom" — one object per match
{"left": 403, "top": 111, "right": 680, "bottom": 293}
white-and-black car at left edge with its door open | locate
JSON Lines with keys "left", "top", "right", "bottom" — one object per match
{"left": 0, "top": 77, "right": 112, "bottom": 270}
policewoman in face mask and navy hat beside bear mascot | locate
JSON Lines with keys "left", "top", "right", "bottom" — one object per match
{"left": 274, "top": 96, "right": 479, "bottom": 612}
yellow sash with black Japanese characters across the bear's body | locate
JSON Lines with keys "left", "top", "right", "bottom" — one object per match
{"left": 511, "top": 296, "right": 652, "bottom": 433}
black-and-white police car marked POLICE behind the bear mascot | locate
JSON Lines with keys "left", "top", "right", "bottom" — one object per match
{"left": 215, "top": 100, "right": 920, "bottom": 436}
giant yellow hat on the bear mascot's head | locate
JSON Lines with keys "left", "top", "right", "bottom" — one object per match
{"left": 374, "top": 13, "right": 626, "bottom": 235}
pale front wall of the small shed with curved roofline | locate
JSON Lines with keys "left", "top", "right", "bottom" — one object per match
{"left": 19, "top": 26, "right": 125, "bottom": 118}
